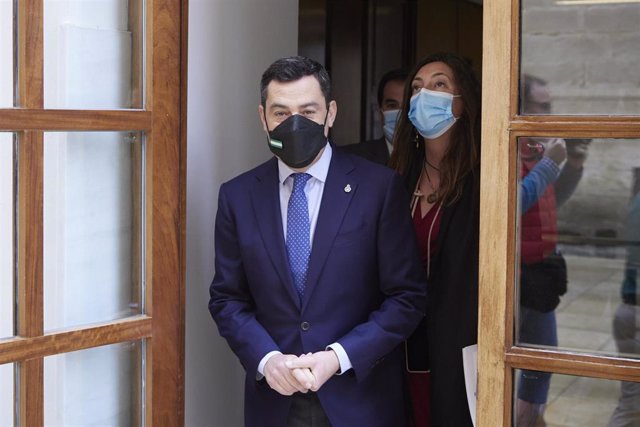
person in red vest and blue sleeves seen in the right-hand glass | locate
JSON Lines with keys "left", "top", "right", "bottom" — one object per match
{"left": 516, "top": 75, "right": 590, "bottom": 427}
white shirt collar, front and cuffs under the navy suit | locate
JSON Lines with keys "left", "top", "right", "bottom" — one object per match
{"left": 256, "top": 143, "right": 352, "bottom": 380}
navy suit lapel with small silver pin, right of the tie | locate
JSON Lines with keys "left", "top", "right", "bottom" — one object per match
{"left": 302, "top": 149, "right": 357, "bottom": 310}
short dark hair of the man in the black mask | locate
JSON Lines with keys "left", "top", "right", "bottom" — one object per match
{"left": 260, "top": 56, "right": 331, "bottom": 107}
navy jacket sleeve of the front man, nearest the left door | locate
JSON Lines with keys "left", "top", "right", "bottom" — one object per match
{"left": 209, "top": 184, "right": 280, "bottom": 373}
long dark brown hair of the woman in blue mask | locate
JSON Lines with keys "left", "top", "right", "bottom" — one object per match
{"left": 389, "top": 53, "right": 480, "bottom": 205}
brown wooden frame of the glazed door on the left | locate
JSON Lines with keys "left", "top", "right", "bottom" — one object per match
{"left": 0, "top": 0, "right": 188, "bottom": 426}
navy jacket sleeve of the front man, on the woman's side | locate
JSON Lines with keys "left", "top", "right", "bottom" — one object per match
{"left": 338, "top": 173, "right": 426, "bottom": 381}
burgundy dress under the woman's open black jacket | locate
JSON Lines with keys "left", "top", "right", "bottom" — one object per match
{"left": 408, "top": 203, "right": 442, "bottom": 427}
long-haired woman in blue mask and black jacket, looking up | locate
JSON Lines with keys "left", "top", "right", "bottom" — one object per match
{"left": 390, "top": 53, "right": 480, "bottom": 427}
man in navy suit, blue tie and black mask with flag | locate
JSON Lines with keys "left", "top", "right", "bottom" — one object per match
{"left": 209, "top": 57, "right": 426, "bottom": 427}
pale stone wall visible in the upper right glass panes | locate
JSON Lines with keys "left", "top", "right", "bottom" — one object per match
{"left": 521, "top": 0, "right": 640, "bottom": 244}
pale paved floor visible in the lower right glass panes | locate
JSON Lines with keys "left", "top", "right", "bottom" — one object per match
{"left": 532, "top": 256, "right": 640, "bottom": 427}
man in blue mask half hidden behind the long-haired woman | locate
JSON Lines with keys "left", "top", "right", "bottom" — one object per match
{"left": 342, "top": 69, "right": 409, "bottom": 165}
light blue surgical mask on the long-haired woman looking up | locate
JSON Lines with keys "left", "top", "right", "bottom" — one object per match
{"left": 409, "top": 88, "right": 460, "bottom": 139}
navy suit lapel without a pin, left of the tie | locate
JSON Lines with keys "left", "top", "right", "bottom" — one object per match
{"left": 251, "top": 158, "right": 300, "bottom": 307}
